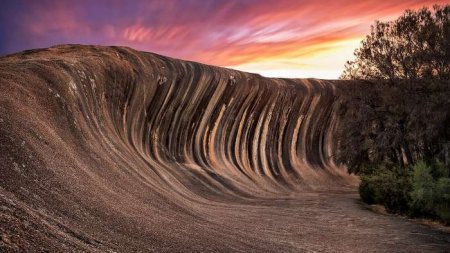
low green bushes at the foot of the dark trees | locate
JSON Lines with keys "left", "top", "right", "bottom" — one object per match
{"left": 359, "top": 161, "right": 450, "bottom": 224}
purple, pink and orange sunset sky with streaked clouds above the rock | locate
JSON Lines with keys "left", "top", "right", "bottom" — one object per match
{"left": 0, "top": 0, "right": 450, "bottom": 79}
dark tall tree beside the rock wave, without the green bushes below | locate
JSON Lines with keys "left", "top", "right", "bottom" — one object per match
{"left": 336, "top": 5, "right": 450, "bottom": 173}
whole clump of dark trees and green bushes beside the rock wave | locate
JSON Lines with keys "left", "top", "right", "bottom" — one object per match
{"left": 335, "top": 5, "right": 450, "bottom": 224}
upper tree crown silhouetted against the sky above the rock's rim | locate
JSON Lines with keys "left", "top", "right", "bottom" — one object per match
{"left": 341, "top": 5, "right": 450, "bottom": 82}
